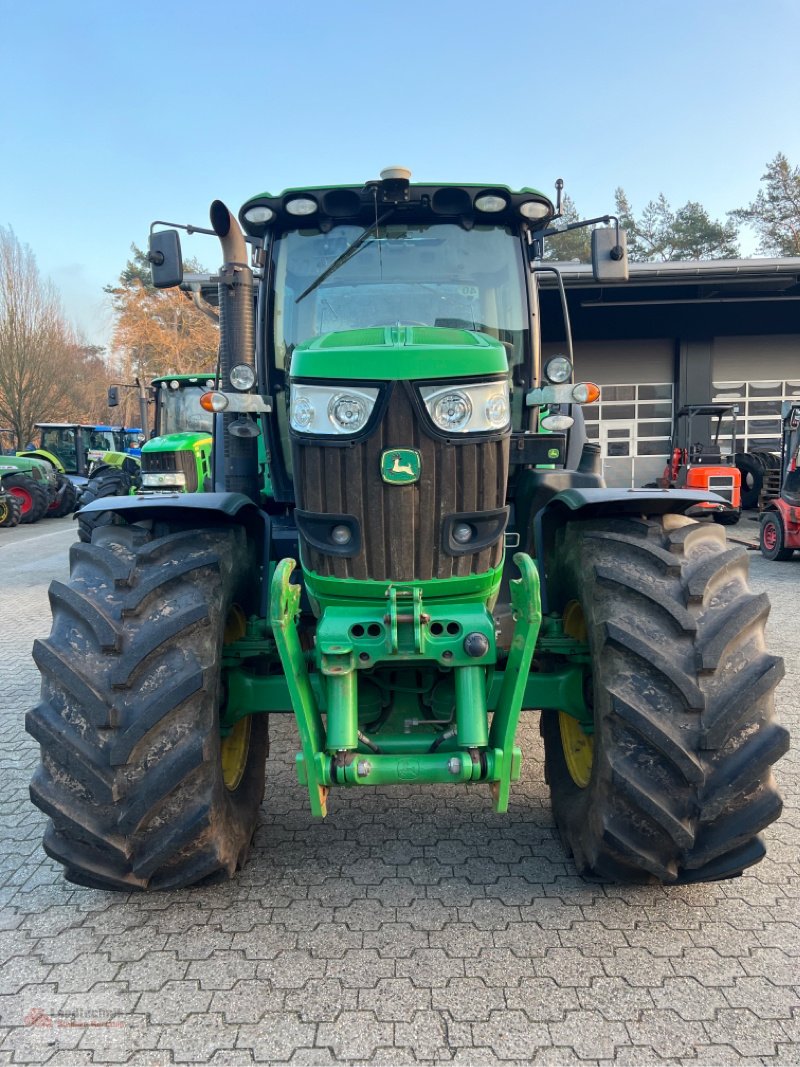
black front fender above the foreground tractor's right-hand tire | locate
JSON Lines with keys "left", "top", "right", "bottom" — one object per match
{"left": 533, "top": 488, "right": 729, "bottom": 612}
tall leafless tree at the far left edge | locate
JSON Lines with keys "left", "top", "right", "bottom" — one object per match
{"left": 0, "top": 226, "right": 80, "bottom": 448}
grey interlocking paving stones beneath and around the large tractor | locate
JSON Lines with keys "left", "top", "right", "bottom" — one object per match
{"left": 0, "top": 520, "right": 800, "bottom": 1065}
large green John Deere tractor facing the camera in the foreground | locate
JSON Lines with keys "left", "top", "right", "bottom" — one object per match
{"left": 27, "top": 169, "right": 787, "bottom": 890}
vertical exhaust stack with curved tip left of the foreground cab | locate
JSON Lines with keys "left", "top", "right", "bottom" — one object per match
{"left": 210, "top": 201, "right": 260, "bottom": 503}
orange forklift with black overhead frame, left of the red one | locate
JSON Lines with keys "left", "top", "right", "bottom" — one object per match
{"left": 652, "top": 403, "right": 741, "bottom": 526}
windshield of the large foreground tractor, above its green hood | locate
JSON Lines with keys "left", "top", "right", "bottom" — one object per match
{"left": 273, "top": 221, "right": 529, "bottom": 371}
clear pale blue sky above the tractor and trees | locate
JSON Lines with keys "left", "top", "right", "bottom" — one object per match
{"left": 0, "top": 0, "right": 800, "bottom": 345}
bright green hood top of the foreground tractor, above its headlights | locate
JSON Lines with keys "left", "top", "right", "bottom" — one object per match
{"left": 291, "top": 325, "right": 508, "bottom": 381}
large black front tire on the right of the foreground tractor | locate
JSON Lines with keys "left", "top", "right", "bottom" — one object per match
{"left": 541, "top": 515, "right": 788, "bottom": 882}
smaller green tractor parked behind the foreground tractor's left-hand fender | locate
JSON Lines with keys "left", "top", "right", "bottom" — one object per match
{"left": 77, "top": 375, "right": 215, "bottom": 542}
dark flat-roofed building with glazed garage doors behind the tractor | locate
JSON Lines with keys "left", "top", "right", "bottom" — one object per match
{"left": 542, "top": 258, "right": 800, "bottom": 487}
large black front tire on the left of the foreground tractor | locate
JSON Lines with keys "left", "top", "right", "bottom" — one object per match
{"left": 26, "top": 526, "right": 269, "bottom": 890}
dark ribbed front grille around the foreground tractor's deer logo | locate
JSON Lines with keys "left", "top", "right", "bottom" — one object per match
{"left": 293, "top": 384, "right": 509, "bottom": 582}
